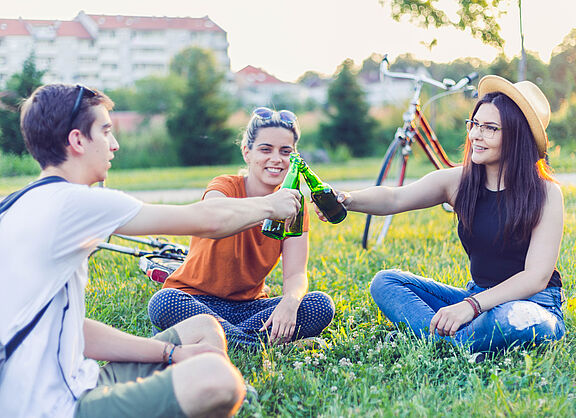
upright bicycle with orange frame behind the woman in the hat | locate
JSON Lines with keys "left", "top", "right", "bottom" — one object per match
{"left": 362, "top": 56, "right": 478, "bottom": 249}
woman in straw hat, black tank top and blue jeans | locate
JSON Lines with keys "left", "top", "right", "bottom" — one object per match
{"left": 332, "top": 75, "right": 565, "bottom": 352}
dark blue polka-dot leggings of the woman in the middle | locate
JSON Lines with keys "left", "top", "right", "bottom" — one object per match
{"left": 148, "top": 288, "right": 335, "bottom": 346}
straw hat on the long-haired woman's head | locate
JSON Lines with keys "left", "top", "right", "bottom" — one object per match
{"left": 478, "top": 75, "right": 551, "bottom": 158}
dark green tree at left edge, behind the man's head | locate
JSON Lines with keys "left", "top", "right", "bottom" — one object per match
{"left": 0, "top": 54, "right": 45, "bottom": 155}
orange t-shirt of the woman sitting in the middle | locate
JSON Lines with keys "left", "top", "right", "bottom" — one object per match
{"left": 163, "top": 176, "right": 309, "bottom": 301}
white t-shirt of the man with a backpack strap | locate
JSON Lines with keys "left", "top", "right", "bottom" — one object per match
{"left": 0, "top": 183, "right": 142, "bottom": 418}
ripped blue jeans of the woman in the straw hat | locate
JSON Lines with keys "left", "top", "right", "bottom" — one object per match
{"left": 370, "top": 270, "right": 566, "bottom": 352}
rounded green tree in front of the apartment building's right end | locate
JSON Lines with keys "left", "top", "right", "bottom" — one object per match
{"left": 166, "top": 47, "right": 234, "bottom": 165}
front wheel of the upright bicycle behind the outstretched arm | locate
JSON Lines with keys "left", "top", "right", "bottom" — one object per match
{"left": 362, "top": 137, "right": 408, "bottom": 249}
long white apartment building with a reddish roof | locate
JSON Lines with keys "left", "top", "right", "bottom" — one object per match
{"left": 0, "top": 12, "right": 230, "bottom": 89}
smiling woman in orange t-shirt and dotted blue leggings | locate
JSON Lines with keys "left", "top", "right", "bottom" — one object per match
{"left": 148, "top": 107, "right": 334, "bottom": 345}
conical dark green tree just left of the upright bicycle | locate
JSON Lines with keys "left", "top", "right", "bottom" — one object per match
{"left": 320, "top": 59, "right": 376, "bottom": 157}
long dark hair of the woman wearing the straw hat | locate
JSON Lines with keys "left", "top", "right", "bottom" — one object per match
{"left": 454, "top": 92, "right": 554, "bottom": 240}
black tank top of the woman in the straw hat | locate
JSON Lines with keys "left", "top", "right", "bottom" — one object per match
{"left": 458, "top": 188, "right": 562, "bottom": 287}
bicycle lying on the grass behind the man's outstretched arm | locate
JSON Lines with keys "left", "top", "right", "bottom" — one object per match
{"left": 91, "top": 234, "right": 188, "bottom": 283}
